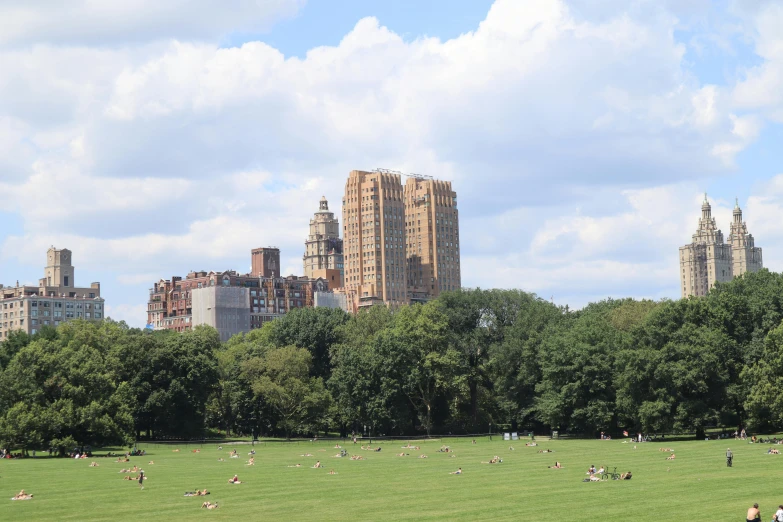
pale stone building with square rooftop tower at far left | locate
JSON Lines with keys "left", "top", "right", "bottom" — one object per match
{"left": 0, "top": 247, "right": 105, "bottom": 341}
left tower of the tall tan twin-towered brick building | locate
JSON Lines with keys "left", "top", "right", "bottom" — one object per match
{"left": 343, "top": 169, "right": 408, "bottom": 307}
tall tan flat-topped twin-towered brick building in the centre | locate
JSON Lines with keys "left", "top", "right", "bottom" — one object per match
{"left": 343, "top": 169, "right": 461, "bottom": 309}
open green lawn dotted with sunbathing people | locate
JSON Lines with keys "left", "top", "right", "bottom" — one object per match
{"left": 0, "top": 437, "right": 783, "bottom": 522}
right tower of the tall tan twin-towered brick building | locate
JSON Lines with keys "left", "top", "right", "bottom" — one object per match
{"left": 404, "top": 175, "right": 461, "bottom": 302}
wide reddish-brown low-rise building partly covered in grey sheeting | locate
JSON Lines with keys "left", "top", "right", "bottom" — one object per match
{"left": 147, "top": 248, "right": 329, "bottom": 337}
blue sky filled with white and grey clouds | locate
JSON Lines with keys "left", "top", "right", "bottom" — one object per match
{"left": 0, "top": 0, "right": 783, "bottom": 326}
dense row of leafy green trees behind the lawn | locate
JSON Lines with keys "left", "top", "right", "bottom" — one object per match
{"left": 0, "top": 270, "right": 783, "bottom": 449}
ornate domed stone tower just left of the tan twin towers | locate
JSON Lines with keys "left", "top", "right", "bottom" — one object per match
{"left": 303, "top": 197, "right": 343, "bottom": 288}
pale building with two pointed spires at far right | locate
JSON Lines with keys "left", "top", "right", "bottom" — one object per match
{"left": 680, "top": 194, "right": 763, "bottom": 297}
